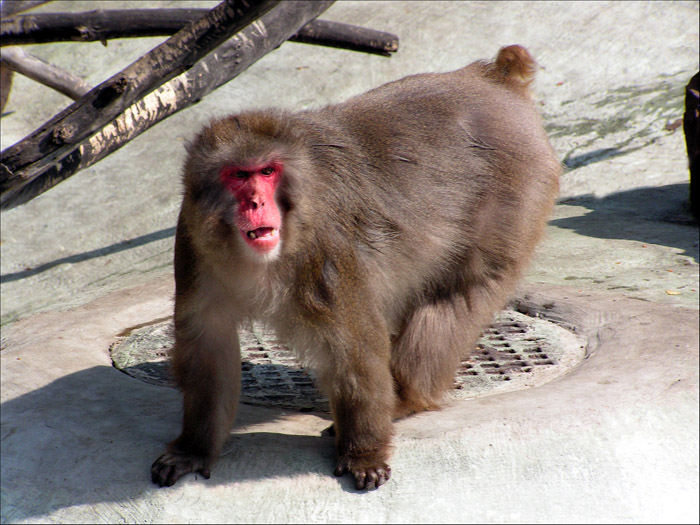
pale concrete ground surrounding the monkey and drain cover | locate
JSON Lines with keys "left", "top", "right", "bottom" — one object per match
{"left": 0, "top": 1, "right": 700, "bottom": 523}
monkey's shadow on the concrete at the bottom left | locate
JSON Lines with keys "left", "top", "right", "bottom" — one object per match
{"left": 0, "top": 364, "right": 356, "bottom": 523}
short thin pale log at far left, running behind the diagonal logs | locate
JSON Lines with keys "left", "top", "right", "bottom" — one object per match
{"left": 0, "top": 47, "right": 92, "bottom": 100}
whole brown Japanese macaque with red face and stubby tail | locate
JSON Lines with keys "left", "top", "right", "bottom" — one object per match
{"left": 151, "top": 46, "right": 560, "bottom": 489}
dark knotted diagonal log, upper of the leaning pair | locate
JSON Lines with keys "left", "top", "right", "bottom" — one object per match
{"left": 0, "top": 0, "right": 279, "bottom": 199}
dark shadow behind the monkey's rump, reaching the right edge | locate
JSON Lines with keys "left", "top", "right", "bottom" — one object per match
{"left": 551, "top": 184, "right": 699, "bottom": 262}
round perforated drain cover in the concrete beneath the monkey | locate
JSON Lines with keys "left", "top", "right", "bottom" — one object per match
{"left": 110, "top": 304, "right": 585, "bottom": 411}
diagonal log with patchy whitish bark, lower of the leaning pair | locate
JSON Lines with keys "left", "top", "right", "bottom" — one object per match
{"left": 0, "top": 0, "right": 333, "bottom": 210}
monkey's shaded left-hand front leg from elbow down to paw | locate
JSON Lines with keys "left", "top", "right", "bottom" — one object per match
{"left": 151, "top": 308, "right": 241, "bottom": 487}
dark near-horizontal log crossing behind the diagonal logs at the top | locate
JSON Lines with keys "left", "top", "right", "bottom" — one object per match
{"left": 0, "top": 8, "right": 399, "bottom": 56}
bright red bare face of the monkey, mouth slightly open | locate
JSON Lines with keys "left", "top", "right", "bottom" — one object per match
{"left": 219, "top": 162, "right": 282, "bottom": 255}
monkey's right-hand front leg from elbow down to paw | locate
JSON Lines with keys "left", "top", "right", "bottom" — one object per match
{"left": 325, "top": 342, "right": 396, "bottom": 489}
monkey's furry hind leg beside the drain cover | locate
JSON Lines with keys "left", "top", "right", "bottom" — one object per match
{"left": 391, "top": 296, "right": 480, "bottom": 419}
